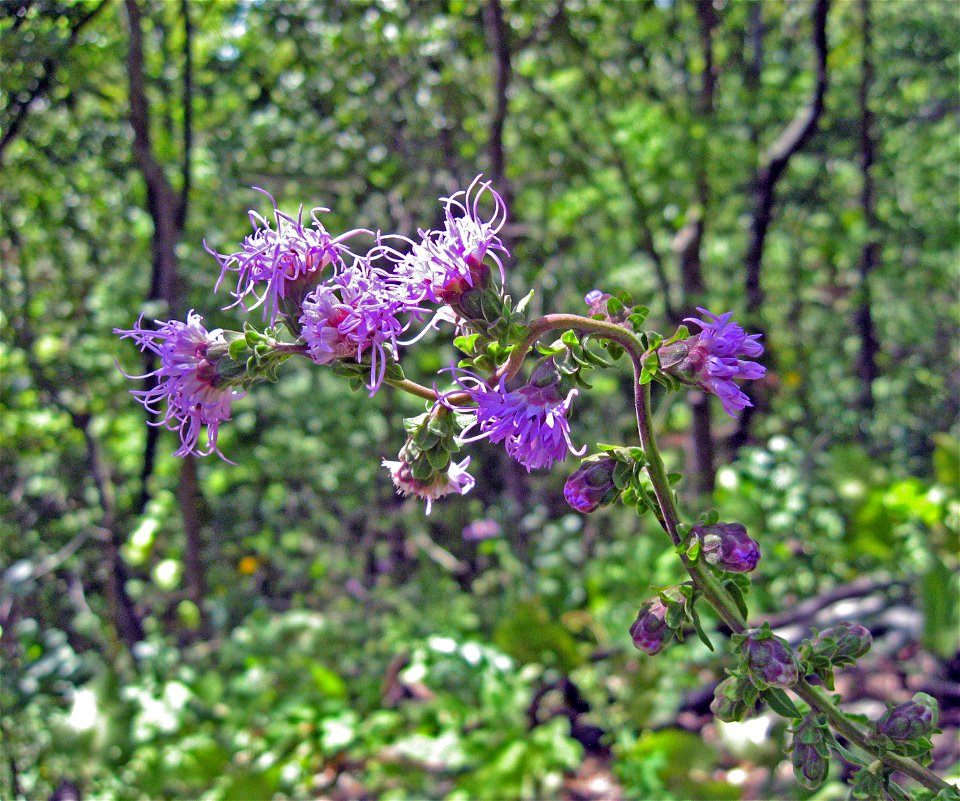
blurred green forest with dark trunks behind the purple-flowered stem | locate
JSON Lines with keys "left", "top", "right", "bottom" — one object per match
{"left": 0, "top": 0, "right": 960, "bottom": 801}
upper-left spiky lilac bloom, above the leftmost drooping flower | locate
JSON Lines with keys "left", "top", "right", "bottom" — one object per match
{"left": 204, "top": 187, "right": 370, "bottom": 325}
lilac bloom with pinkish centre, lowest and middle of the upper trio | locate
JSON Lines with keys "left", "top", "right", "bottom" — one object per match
{"left": 300, "top": 259, "right": 411, "bottom": 395}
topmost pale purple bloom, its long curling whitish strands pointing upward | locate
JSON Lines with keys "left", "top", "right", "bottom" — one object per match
{"left": 380, "top": 175, "right": 509, "bottom": 303}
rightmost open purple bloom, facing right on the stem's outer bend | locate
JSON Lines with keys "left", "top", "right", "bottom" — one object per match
{"left": 684, "top": 307, "right": 766, "bottom": 415}
